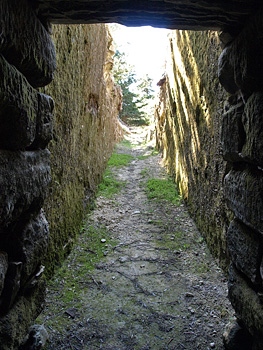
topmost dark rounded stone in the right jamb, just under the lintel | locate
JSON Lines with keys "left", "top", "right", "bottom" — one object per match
{"left": 219, "top": 9, "right": 263, "bottom": 97}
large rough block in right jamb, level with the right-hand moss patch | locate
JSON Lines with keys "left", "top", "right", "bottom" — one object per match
{"left": 224, "top": 169, "right": 263, "bottom": 233}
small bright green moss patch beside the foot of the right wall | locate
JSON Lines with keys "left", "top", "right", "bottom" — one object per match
{"left": 146, "top": 178, "right": 181, "bottom": 204}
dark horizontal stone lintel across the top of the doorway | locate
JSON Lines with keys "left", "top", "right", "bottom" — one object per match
{"left": 36, "top": 0, "right": 262, "bottom": 31}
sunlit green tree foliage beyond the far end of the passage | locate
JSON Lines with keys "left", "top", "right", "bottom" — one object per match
{"left": 113, "top": 50, "right": 154, "bottom": 125}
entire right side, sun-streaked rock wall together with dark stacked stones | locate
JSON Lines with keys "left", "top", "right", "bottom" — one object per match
{"left": 156, "top": 10, "right": 263, "bottom": 350}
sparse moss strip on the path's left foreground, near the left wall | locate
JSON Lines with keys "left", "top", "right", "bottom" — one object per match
{"left": 37, "top": 224, "right": 118, "bottom": 332}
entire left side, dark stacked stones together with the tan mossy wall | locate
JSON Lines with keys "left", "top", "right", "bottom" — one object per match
{"left": 0, "top": 0, "right": 120, "bottom": 350}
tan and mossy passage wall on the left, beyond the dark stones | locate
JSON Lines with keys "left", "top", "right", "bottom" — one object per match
{"left": 44, "top": 24, "right": 121, "bottom": 273}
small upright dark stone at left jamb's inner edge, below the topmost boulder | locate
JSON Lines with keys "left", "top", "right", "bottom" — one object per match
{"left": 30, "top": 93, "right": 54, "bottom": 149}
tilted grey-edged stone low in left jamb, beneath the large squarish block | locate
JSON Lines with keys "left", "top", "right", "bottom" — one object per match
{"left": 1, "top": 210, "right": 49, "bottom": 284}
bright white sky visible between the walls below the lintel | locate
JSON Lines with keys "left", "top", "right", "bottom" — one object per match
{"left": 111, "top": 24, "right": 169, "bottom": 88}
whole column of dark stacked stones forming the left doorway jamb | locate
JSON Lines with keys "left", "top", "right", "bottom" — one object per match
{"left": 0, "top": 0, "right": 56, "bottom": 350}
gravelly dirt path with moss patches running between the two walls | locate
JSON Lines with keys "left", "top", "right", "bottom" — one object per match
{"left": 39, "top": 127, "right": 232, "bottom": 350}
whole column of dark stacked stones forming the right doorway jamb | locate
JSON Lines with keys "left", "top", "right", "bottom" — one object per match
{"left": 219, "top": 6, "right": 263, "bottom": 350}
